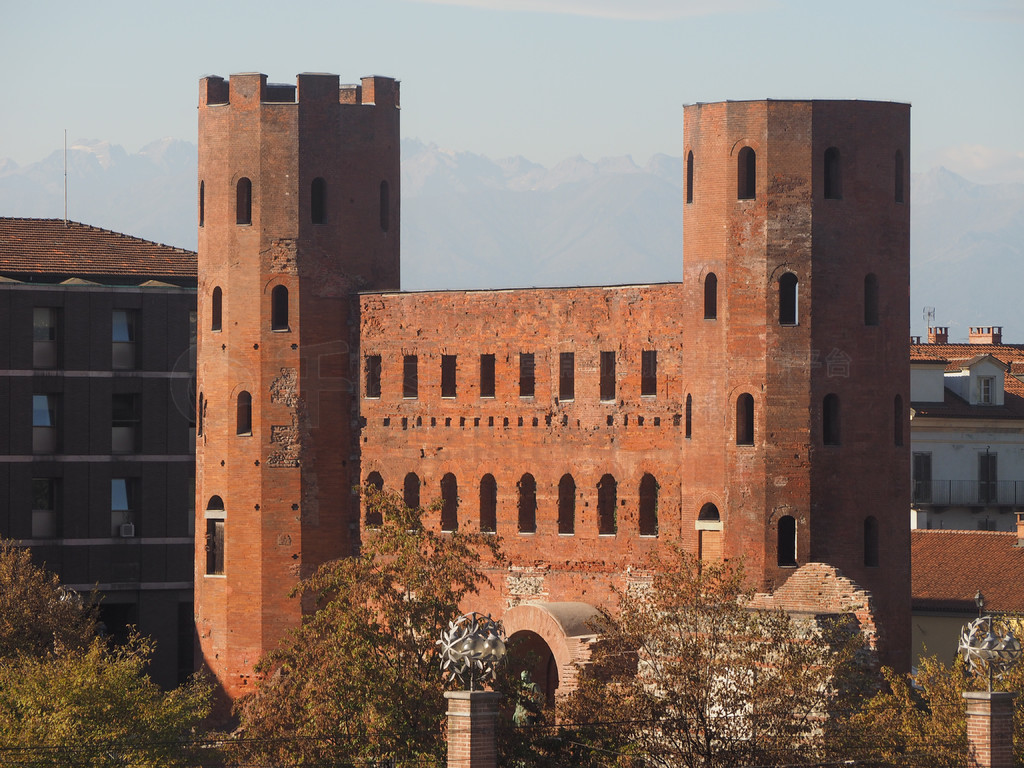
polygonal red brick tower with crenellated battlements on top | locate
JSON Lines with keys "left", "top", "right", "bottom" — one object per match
{"left": 196, "top": 74, "right": 399, "bottom": 698}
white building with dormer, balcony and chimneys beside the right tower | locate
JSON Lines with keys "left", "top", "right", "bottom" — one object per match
{"left": 910, "top": 326, "right": 1024, "bottom": 531}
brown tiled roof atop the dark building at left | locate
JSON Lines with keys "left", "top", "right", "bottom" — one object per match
{"left": 0, "top": 217, "right": 197, "bottom": 283}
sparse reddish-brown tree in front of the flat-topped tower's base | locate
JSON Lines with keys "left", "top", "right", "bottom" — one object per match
{"left": 562, "top": 547, "right": 873, "bottom": 768}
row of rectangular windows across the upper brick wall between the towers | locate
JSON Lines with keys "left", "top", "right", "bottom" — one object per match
{"left": 364, "top": 349, "right": 657, "bottom": 401}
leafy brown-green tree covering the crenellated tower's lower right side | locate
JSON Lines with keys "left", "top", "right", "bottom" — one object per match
{"left": 238, "top": 486, "right": 500, "bottom": 765}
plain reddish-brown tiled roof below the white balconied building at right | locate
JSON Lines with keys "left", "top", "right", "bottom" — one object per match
{"left": 910, "top": 529, "right": 1024, "bottom": 612}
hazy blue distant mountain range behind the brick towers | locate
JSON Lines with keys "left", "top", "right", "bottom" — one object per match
{"left": 0, "top": 139, "right": 1024, "bottom": 341}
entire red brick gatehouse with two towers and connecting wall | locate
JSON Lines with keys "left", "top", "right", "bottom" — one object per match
{"left": 197, "top": 75, "right": 909, "bottom": 696}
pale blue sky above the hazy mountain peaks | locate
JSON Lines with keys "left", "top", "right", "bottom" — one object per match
{"left": 0, "top": 0, "right": 1024, "bottom": 183}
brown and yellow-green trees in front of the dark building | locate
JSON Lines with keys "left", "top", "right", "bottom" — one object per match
{"left": 0, "top": 543, "right": 210, "bottom": 768}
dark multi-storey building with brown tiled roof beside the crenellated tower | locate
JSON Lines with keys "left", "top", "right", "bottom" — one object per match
{"left": 0, "top": 218, "right": 197, "bottom": 686}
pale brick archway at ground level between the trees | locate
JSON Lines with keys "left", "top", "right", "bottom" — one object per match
{"left": 502, "top": 602, "right": 600, "bottom": 703}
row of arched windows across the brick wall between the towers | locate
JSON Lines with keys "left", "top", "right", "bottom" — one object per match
{"left": 366, "top": 472, "right": 659, "bottom": 537}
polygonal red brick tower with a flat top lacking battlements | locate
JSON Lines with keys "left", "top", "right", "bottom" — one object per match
{"left": 681, "top": 100, "right": 910, "bottom": 669}
